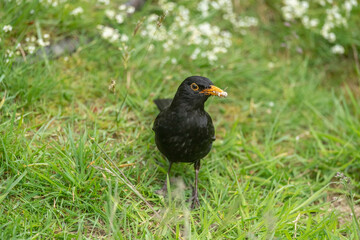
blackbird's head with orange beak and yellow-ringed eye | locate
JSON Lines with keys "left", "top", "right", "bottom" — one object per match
{"left": 172, "top": 76, "right": 227, "bottom": 108}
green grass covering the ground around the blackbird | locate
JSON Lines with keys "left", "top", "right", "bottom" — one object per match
{"left": 0, "top": 2, "right": 360, "bottom": 239}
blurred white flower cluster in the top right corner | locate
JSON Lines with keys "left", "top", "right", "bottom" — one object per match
{"left": 281, "top": 0, "right": 358, "bottom": 54}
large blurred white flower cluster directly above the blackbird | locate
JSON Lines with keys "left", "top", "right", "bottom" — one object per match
{"left": 140, "top": 0, "right": 257, "bottom": 64}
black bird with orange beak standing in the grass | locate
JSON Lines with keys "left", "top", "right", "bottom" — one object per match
{"left": 153, "top": 76, "right": 227, "bottom": 208}
